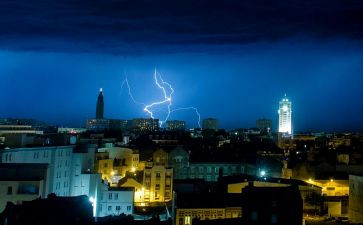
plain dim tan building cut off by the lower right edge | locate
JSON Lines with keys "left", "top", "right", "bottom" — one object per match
{"left": 348, "top": 175, "right": 363, "bottom": 223}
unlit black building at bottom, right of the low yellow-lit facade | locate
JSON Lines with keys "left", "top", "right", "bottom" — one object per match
{"left": 242, "top": 185, "right": 303, "bottom": 225}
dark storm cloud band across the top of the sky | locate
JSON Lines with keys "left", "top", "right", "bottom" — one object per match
{"left": 0, "top": 0, "right": 363, "bottom": 53}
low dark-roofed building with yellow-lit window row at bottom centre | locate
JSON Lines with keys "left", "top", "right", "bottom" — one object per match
{"left": 175, "top": 193, "right": 242, "bottom": 225}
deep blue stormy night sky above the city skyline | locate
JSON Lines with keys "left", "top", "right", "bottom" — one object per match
{"left": 0, "top": 0, "right": 363, "bottom": 131}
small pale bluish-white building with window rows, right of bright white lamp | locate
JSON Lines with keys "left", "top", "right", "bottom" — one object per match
{"left": 96, "top": 188, "right": 134, "bottom": 217}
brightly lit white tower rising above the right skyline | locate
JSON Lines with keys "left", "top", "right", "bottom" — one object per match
{"left": 278, "top": 94, "right": 292, "bottom": 135}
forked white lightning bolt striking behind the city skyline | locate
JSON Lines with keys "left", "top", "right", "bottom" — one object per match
{"left": 121, "top": 69, "right": 201, "bottom": 127}
